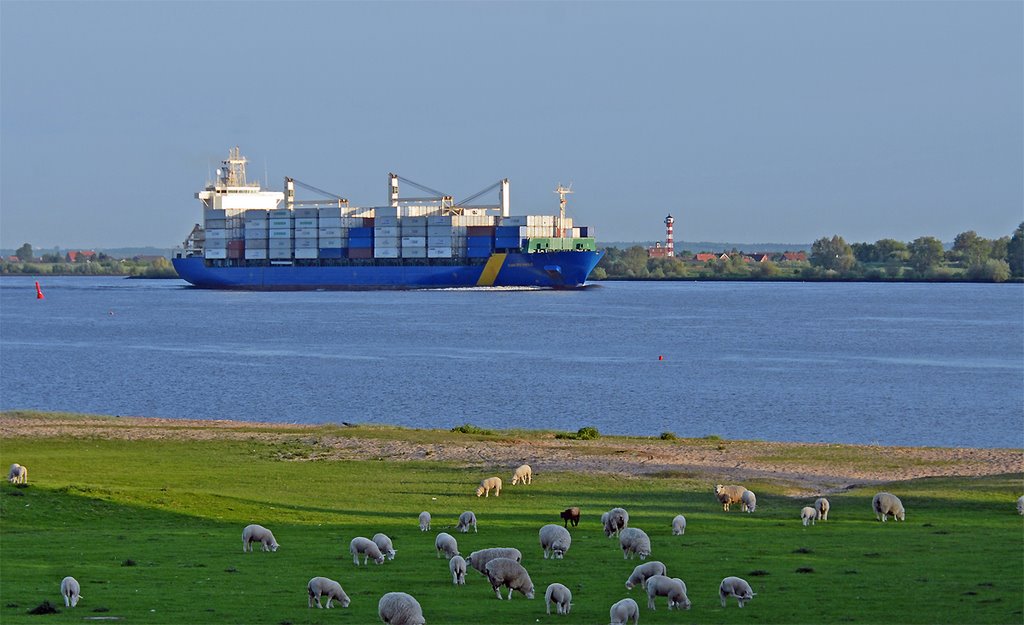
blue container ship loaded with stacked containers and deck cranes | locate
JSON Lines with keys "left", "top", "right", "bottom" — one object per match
{"left": 173, "top": 148, "right": 603, "bottom": 291}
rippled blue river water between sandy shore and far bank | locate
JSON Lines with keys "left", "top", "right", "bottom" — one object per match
{"left": 0, "top": 278, "right": 1024, "bottom": 447}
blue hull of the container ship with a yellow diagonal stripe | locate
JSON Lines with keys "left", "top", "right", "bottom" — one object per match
{"left": 173, "top": 246, "right": 604, "bottom": 291}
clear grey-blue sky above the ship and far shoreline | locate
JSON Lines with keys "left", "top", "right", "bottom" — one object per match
{"left": 0, "top": 0, "right": 1024, "bottom": 248}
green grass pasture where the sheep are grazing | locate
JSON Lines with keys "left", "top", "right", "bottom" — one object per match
{"left": 0, "top": 411, "right": 1024, "bottom": 625}
